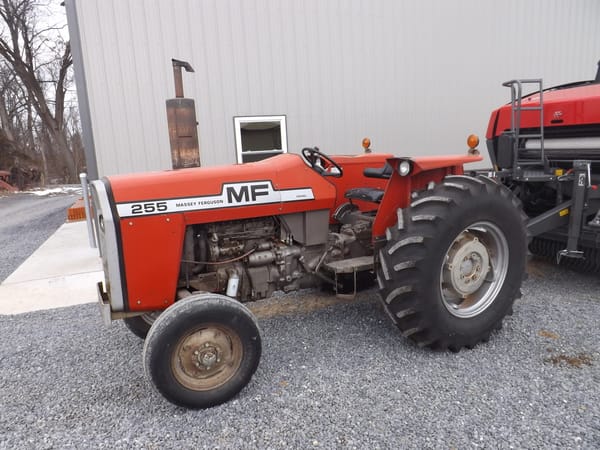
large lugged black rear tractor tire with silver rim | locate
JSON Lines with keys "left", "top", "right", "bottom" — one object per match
{"left": 377, "top": 176, "right": 527, "bottom": 351}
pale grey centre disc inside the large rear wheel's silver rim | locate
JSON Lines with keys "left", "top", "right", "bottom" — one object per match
{"left": 444, "top": 235, "right": 490, "bottom": 298}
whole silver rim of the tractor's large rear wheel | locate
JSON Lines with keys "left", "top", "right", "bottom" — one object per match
{"left": 440, "top": 222, "right": 509, "bottom": 318}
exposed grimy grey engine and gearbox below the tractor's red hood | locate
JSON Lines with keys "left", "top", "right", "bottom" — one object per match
{"left": 179, "top": 216, "right": 373, "bottom": 301}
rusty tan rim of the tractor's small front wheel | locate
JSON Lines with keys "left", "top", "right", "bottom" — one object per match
{"left": 171, "top": 324, "right": 243, "bottom": 391}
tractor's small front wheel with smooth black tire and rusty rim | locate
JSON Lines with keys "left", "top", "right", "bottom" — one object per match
{"left": 143, "top": 294, "right": 261, "bottom": 408}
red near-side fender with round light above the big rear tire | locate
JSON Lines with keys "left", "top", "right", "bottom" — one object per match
{"left": 373, "top": 155, "right": 483, "bottom": 243}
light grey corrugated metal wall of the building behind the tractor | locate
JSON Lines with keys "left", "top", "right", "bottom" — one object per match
{"left": 68, "top": 0, "right": 600, "bottom": 175}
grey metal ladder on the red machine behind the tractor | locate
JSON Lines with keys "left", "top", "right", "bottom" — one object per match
{"left": 502, "top": 78, "right": 550, "bottom": 181}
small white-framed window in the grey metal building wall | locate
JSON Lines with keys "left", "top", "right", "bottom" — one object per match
{"left": 233, "top": 116, "right": 287, "bottom": 164}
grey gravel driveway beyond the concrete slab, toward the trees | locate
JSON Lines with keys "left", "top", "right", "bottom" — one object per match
{"left": 0, "top": 192, "right": 78, "bottom": 283}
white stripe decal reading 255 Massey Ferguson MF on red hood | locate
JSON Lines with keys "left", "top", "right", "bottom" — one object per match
{"left": 117, "top": 180, "right": 315, "bottom": 217}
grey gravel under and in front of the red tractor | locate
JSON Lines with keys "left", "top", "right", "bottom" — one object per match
{"left": 0, "top": 263, "right": 600, "bottom": 449}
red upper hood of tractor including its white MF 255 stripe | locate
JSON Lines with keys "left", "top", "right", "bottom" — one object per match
{"left": 103, "top": 154, "right": 335, "bottom": 217}
